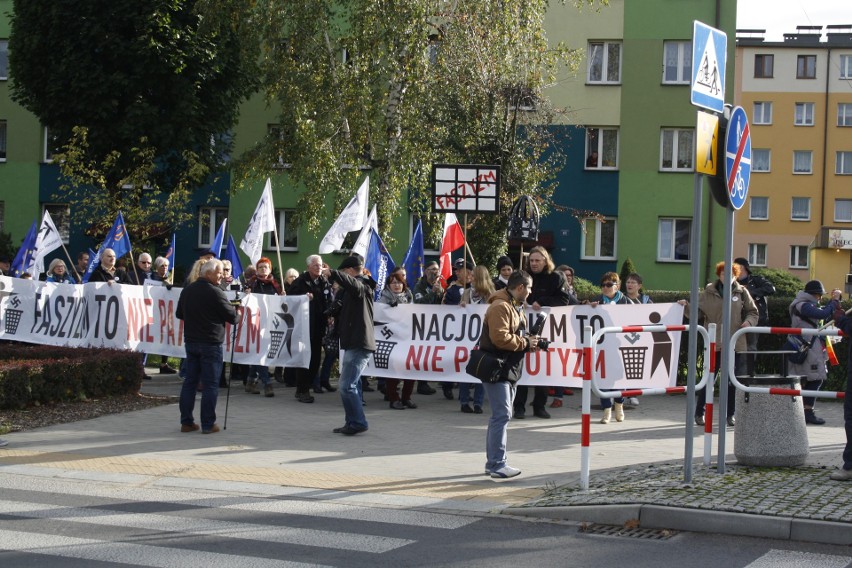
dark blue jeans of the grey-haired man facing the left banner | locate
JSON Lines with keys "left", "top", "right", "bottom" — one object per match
{"left": 178, "top": 343, "right": 222, "bottom": 430}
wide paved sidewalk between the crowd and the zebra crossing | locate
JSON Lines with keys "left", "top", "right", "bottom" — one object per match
{"left": 0, "top": 375, "right": 852, "bottom": 544}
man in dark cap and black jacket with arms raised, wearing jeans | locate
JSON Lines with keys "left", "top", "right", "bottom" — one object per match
{"left": 324, "top": 256, "right": 376, "bottom": 436}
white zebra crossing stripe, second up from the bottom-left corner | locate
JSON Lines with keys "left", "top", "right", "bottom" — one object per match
{"left": 0, "top": 501, "right": 415, "bottom": 552}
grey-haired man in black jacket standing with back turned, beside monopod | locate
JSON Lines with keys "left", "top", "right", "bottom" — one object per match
{"left": 176, "top": 259, "right": 237, "bottom": 434}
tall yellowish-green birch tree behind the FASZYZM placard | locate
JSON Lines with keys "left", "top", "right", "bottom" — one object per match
{"left": 237, "top": 0, "right": 598, "bottom": 264}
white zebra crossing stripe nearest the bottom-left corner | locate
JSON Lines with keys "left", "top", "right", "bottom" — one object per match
{"left": 0, "top": 529, "right": 331, "bottom": 568}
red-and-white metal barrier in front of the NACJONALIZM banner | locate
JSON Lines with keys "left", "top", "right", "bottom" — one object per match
{"left": 580, "top": 324, "right": 716, "bottom": 489}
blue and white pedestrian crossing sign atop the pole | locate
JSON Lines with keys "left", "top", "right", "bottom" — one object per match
{"left": 691, "top": 20, "right": 728, "bottom": 112}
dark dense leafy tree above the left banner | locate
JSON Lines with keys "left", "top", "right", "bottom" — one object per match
{"left": 9, "top": 0, "right": 259, "bottom": 240}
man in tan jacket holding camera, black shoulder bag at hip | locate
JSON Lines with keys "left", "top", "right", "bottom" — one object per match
{"left": 479, "top": 271, "right": 547, "bottom": 479}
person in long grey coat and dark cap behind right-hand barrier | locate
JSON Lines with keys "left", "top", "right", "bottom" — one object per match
{"left": 788, "top": 280, "right": 840, "bottom": 425}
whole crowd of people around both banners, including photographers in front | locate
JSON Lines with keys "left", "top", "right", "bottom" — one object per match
{"left": 0, "top": 246, "right": 852, "bottom": 480}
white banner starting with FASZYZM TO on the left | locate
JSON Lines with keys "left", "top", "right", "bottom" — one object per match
{"left": 0, "top": 276, "right": 311, "bottom": 368}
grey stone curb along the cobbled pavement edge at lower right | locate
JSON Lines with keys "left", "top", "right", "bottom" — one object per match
{"left": 500, "top": 504, "right": 852, "bottom": 546}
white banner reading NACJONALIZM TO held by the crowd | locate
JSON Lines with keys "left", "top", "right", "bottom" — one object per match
{"left": 364, "top": 304, "right": 683, "bottom": 389}
